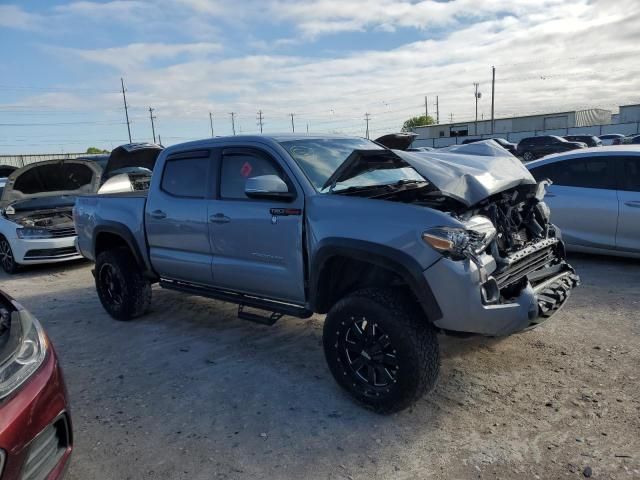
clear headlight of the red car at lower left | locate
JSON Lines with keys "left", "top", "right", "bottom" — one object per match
{"left": 0, "top": 310, "right": 48, "bottom": 400}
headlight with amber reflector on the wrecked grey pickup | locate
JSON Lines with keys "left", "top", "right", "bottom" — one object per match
{"left": 422, "top": 215, "right": 496, "bottom": 260}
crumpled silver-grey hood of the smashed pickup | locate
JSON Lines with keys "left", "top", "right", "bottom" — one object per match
{"left": 394, "top": 142, "right": 537, "bottom": 207}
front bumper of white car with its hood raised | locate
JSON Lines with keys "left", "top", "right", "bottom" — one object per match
{"left": 10, "top": 236, "right": 82, "bottom": 265}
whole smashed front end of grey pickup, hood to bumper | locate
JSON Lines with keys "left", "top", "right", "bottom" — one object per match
{"left": 389, "top": 147, "right": 579, "bottom": 335}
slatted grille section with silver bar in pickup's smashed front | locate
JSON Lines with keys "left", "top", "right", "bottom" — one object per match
{"left": 494, "top": 238, "right": 558, "bottom": 289}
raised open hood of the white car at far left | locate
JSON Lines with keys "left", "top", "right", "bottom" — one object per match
{"left": 0, "top": 159, "right": 102, "bottom": 208}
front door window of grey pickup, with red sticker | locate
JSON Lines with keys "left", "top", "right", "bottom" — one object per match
{"left": 220, "top": 153, "right": 284, "bottom": 199}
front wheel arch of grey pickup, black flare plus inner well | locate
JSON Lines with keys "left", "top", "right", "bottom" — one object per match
{"left": 309, "top": 238, "right": 442, "bottom": 322}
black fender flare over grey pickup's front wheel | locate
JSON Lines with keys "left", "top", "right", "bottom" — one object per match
{"left": 309, "top": 238, "right": 442, "bottom": 322}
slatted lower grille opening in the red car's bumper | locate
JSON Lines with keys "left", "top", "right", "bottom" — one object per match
{"left": 20, "top": 415, "right": 70, "bottom": 480}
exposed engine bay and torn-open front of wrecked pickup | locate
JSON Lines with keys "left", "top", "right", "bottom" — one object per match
{"left": 362, "top": 182, "right": 579, "bottom": 317}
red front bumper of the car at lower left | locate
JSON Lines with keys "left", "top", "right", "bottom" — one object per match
{"left": 0, "top": 334, "right": 72, "bottom": 480}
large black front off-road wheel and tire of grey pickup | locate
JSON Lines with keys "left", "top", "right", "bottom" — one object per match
{"left": 323, "top": 288, "right": 440, "bottom": 413}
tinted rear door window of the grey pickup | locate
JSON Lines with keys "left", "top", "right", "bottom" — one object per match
{"left": 161, "top": 157, "right": 209, "bottom": 198}
